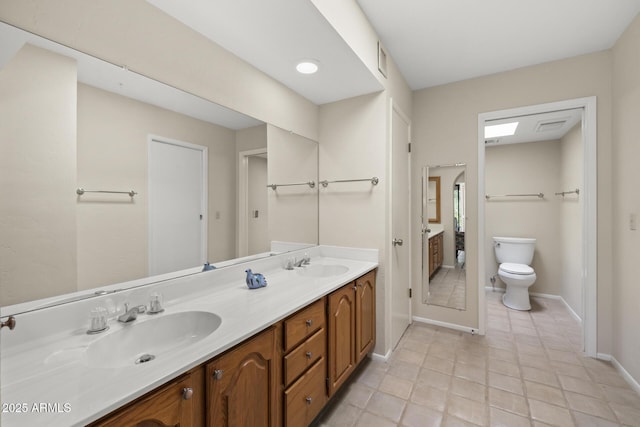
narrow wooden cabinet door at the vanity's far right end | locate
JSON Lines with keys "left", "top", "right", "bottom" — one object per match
{"left": 356, "top": 270, "right": 376, "bottom": 363}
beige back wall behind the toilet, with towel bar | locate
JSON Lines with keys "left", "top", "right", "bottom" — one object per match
{"left": 485, "top": 140, "right": 562, "bottom": 295}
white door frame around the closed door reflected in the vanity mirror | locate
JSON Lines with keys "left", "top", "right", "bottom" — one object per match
{"left": 147, "top": 134, "right": 209, "bottom": 274}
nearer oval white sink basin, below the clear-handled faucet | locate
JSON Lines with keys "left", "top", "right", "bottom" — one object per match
{"left": 85, "top": 311, "right": 222, "bottom": 368}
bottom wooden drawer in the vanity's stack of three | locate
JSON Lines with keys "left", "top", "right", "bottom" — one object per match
{"left": 284, "top": 357, "right": 327, "bottom": 427}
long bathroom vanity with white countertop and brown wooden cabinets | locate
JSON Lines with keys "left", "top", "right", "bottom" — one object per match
{"left": 2, "top": 246, "right": 377, "bottom": 426}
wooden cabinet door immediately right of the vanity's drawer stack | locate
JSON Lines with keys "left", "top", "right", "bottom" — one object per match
{"left": 327, "top": 282, "right": 356, "bottom": 396}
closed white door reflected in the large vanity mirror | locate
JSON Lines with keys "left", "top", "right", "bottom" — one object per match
{"left": 149, "top": 137, "right": 207, "bottom": 275}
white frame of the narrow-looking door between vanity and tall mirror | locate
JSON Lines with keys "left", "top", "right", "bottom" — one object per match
{"left": 385, "top": 98, "right": 413, "bottom": 354}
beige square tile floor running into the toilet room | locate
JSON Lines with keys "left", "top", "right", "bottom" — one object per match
{"left": 315, "top": 292, "right": 640, "bottom": 427}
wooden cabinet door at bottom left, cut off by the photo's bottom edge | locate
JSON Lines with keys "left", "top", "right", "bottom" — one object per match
{"left": 91, "top": 374, "right": 203, "bottom": 427}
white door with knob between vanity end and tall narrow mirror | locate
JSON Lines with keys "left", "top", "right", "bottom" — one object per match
{"left": 391, "top": 106, "right": 411, "bottom": 348}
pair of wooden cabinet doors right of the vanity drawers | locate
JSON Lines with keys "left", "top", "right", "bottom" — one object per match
{"left": 327, "top": 270, "right": 376, "bottom": 397}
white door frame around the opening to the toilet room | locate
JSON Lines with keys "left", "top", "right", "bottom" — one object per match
{"left": 477, "top": 96, "right": 598, "bottom": 357}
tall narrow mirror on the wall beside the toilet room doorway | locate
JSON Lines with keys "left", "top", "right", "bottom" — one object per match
{"left": 422, "top": 163, "right": 467, "bottom": 310}
